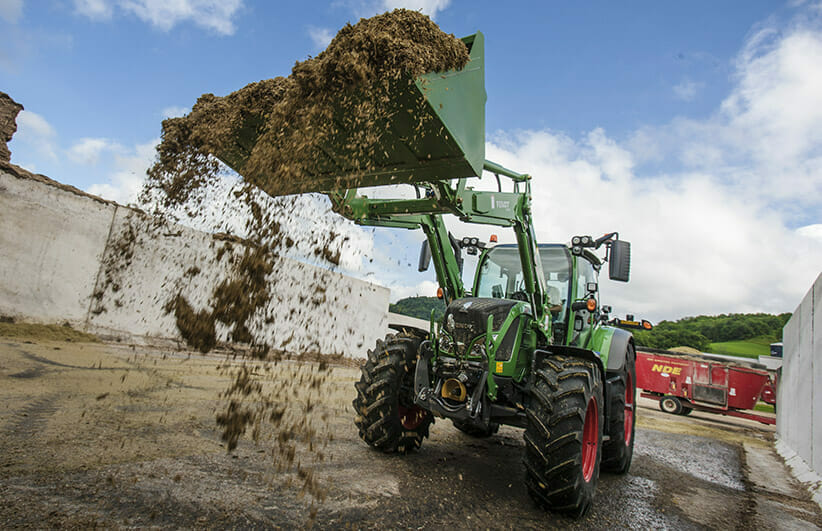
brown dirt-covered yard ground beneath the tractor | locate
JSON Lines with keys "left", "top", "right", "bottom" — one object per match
{"left": 0, "top": 337, "right": 822, "bottom": 529}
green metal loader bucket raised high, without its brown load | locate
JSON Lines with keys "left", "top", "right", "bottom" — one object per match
{"left": 216, "top": 32, "right": 486, "bottom": 196}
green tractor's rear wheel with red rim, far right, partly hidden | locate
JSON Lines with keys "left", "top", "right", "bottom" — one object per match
{"left": 602, "top": 344, "right": 636, "bottom": 474}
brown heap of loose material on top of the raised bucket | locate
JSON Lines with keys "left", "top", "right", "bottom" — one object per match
{"left": 149, "top": 9, "right": 468, "bottom": 202}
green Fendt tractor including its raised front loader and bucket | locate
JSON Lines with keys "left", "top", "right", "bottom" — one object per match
{"left": 209, "top": 33, "right": 636, "bottom": 516}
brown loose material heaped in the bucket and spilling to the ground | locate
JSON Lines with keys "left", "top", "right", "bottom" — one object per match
{"left": 133, "top": 9, "right": 468, "bottom": 516}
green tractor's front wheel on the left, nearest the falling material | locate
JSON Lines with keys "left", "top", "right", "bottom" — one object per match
{"left": 353, "top": 334, "right": 434, "bottom": 454}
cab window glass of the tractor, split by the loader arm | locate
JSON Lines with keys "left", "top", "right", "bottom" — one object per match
{"left": 475, "top": 245, "right": 571, "bottom": 321}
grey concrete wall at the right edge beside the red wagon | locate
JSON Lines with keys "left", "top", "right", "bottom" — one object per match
{"left": 776, "top": 274, "right": 822, "bottom": 499}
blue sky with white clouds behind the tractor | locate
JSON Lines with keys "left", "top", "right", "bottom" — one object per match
{"left": 0, "top": 0, "right": 822, "bottom": 319}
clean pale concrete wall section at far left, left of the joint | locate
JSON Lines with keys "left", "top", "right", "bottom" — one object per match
{"left": 0, "top": 170, "right": 115, "bottom": 327}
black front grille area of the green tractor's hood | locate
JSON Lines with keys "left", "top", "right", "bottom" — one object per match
{"left": 445, "top": 297, "right": 517, "bottom": 354}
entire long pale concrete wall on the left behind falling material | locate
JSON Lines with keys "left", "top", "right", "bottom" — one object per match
{"left": 0, "top": 168, "right": 389, "bottom": 357}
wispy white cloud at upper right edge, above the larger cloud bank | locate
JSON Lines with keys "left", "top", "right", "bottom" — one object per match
{"left": 631, "top": 14, "right": 822, "bottom": 208}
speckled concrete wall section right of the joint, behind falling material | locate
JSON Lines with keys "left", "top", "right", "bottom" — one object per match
{"left": 89, "top": 209, "right": 390, "bottom": 357}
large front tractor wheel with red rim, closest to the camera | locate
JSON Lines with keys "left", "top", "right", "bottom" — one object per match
{"left": 524, "top": 356, "right": 604, "bottom": 517}
